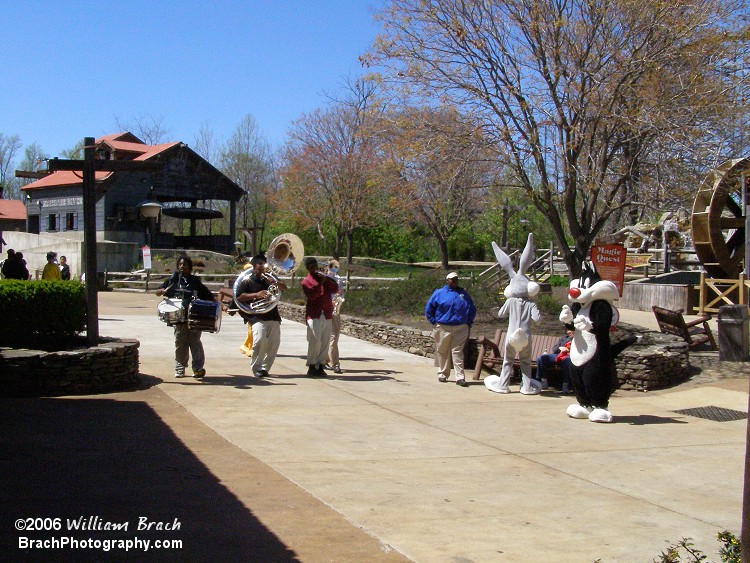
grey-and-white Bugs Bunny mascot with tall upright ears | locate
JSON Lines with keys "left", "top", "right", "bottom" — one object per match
{"left": 484, "top": 233, "right": 541, "bottom": 395}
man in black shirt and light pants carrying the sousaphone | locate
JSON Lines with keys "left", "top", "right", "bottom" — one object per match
{"left": 236, "top": 254, "right": 287, "bottom": 377}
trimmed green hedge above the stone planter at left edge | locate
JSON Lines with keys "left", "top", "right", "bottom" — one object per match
{"left": 0, "top": 280, "right": 86, "bottom": 348}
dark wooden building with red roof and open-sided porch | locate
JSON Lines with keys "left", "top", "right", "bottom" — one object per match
{"left": 21, "top": 132, "right": 243, "bottom": 254}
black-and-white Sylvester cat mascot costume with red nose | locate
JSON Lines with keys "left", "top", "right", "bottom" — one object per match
{"left": 560, "top": 263, "right": 636, "bottom": 422}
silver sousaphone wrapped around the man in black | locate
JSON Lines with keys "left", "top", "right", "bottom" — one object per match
{"left": 232, "top": 233, "right": 305, "bottom": 315}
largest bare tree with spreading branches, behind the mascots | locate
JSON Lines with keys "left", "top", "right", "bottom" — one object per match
{"left": 366, "top": 0, "right": 748, "bottom": 275}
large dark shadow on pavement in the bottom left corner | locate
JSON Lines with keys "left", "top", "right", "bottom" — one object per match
{"left": 0, "top": 398, "right": 298, "bottom": 562}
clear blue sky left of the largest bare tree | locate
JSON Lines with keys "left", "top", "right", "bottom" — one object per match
{"left": 0, "top": 0, "right": 381, "bottom": 160}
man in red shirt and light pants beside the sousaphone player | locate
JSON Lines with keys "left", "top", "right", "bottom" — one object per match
{"left": 302, "top": 256, "right": 338, "bottom": 377}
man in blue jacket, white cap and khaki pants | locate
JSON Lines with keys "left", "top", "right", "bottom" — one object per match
{"left": 424, "top": 272, "right": 477, "bottom": 387}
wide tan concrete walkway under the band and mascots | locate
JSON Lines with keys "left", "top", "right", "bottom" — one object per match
{"left": 0, "top": 292, "right": 748, "bottom": 562}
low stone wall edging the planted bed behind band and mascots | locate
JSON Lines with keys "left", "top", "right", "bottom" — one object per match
{"left": 279, "top": 303, "right": 690, "bottom": 391}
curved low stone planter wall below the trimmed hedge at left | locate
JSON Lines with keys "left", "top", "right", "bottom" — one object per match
{"left": 0, "top": 338, "right": 140, "bottom": 397}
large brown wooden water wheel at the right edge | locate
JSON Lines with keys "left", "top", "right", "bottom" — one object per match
{"left": 691, "top": 158, "right": 750, "bottom": 279}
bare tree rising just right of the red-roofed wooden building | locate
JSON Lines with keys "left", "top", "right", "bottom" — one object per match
{"left": 219, "top": 115, "right": 276, "bottom": 253}
